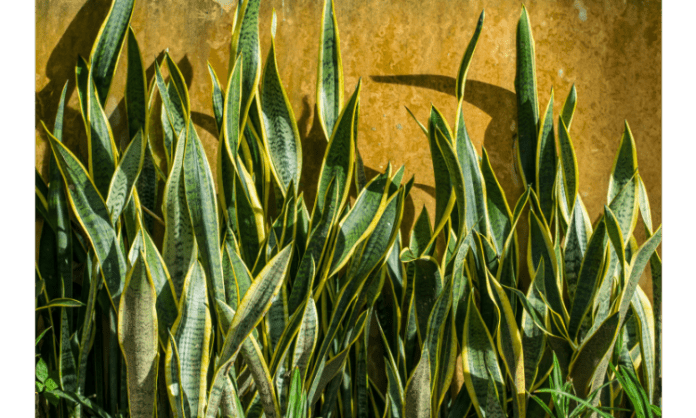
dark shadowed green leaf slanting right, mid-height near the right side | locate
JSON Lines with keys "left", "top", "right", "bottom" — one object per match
{"left": 568, "top": 219, "right": 607, "bottom": 340}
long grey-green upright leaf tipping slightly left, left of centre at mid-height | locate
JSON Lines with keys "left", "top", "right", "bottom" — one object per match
{"left": 183, "top": 122, "right": 225, "bottom": 308}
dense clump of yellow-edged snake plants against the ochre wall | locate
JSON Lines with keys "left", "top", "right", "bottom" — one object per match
{"left": 35, "top": 0, "right": 662, "bottom": 418}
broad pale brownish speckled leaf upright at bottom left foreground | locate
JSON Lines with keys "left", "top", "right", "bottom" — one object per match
{"left": 118, "top": 252, "right": 159, "bottom": 417}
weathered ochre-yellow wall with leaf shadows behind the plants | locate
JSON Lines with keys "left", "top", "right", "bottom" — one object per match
{"left": 35, "top": 0, "right": 662, "bottom": 290}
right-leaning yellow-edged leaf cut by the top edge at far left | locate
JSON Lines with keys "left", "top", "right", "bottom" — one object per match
{"left": 89, "top": 0, "right": 135, "bottom": 106}
